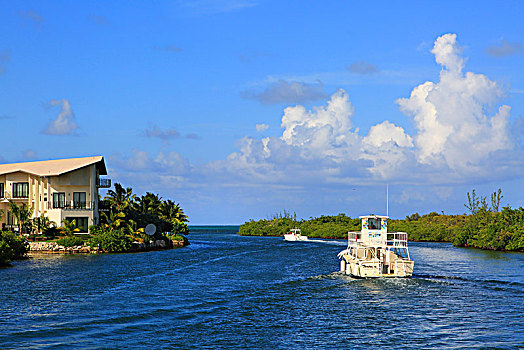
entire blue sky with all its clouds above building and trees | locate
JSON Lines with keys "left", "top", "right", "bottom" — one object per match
{"left": 0, "top": 0, "right": 524, "bottom": 225}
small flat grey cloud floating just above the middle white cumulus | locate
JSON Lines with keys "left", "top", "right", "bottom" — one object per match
{"left": 241, "top": 80, "right": 328, "bottom": 104}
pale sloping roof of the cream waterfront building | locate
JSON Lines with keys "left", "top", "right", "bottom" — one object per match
{"left": 0, "top": 156, "right": 107, "bottom": 176}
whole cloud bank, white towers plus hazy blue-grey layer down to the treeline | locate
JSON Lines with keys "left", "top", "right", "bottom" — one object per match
{"left": 109, "top": 34, "right": 524, "bottom": 221}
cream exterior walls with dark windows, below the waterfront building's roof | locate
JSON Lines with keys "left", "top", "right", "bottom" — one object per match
{"left": 0, "top": 164, "right": 99, "bottom": 232}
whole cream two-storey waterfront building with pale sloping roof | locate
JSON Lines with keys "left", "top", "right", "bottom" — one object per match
{"left": 0, "top": 156, "right": 111, "bottom": 233}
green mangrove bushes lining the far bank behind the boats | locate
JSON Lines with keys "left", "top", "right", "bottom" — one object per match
{"left": 239, "top": 189, "right": 524, "bottom": 251}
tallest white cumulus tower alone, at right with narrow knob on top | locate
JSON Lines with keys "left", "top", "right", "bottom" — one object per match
{"left": 397, "top": 34, "right": 513, "bottom": 174}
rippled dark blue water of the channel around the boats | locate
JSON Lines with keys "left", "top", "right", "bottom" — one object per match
{"left": 0, "top": 228, "right": 524, "bottom": 349}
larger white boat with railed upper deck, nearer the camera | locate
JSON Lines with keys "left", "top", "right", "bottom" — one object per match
{"left": 338, "top": 215, "right": 415, "bottom": 278}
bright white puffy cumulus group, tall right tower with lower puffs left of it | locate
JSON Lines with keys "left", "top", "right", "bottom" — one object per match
{"left": 214, "top": 34, "right": 521, "bottom": 184}
